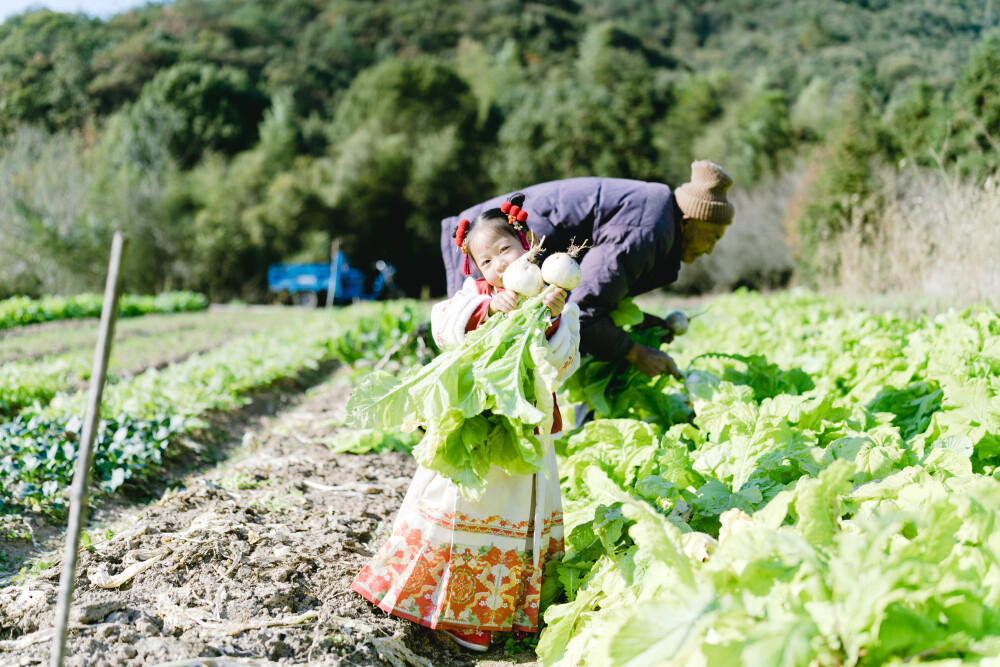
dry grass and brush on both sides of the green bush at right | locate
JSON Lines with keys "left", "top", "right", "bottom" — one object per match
{"left": 671, "top": 165, "right": 1000, "bottom": 314}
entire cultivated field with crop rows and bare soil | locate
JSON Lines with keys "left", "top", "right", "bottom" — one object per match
{"left": 0, "top": 291, "right": 1000, "bottom": 667}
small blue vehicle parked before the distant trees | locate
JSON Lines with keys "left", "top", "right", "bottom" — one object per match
{"left": 267, "top": 253, "right": 401, "bottom": 308}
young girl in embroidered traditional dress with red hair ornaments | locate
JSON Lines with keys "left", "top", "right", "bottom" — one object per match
{"left": 351, "top": 194, "right": 580, "bottom": 651}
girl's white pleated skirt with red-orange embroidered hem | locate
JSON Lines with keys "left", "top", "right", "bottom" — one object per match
{"left": 351, "top": 447, "right": 563, "bottom": 632}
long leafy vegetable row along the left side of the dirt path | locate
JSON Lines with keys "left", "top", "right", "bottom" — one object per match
{"left": 0, "top": 303, "right": 430, "bottom": 512}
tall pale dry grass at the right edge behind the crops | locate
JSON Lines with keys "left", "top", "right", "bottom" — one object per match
{"left": 820, "top": 171, "right": 1000, "bottom": 311}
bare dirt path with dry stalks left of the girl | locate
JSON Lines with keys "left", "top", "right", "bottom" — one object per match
{"left": 0, "top": 377, "right": 534, "bottom": 667}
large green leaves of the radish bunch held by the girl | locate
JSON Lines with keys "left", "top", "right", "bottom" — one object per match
{"left": 347, "top": 284, "right": 558, "bottom": 498}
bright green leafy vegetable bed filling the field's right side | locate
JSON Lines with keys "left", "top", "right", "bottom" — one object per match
{"left": 538, "top": 293, "right": 1000, "bottom": 666}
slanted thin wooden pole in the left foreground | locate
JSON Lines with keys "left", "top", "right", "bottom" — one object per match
{"left": 49, "top": 232, "right": 128, "bottom": 667}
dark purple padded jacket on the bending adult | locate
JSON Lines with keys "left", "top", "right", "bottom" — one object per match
{"left": 441, "top": 177, "right": 681, "bottom": 360}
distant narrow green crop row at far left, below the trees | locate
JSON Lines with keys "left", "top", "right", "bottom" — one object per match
{"left": 0, "top": 292, "right": 208, "bottom": 330}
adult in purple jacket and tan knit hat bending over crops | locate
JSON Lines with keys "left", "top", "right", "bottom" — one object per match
{"left": 441, "top": 160, "right": 734, "bottom": 378}
